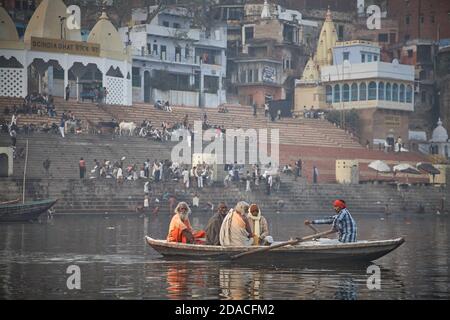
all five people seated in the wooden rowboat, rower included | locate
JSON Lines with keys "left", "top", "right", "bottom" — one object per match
{"left": 167, "top": 200, "right": 357, "bottom": 246}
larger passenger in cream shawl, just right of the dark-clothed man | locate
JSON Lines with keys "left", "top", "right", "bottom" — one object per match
{"left": 220, "top": 201, "right": 253, "bottom": 247}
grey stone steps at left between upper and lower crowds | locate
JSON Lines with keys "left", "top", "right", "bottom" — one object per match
{"left": 0, "top": 133, "right": 173, "bottom": 179}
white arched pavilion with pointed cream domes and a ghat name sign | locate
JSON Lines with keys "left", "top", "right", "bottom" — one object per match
{"left": 0, "top": 0, "right": 132, "bottom": 105}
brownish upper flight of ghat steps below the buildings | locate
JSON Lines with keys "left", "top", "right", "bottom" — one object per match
{"left": 0, "top": 97, "right": 362, "bottom": 149}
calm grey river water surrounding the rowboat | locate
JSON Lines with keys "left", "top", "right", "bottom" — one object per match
{"left": 0, "top": 212, "right": 450, "bottom": 299}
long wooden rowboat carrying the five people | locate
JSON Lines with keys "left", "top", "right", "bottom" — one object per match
{"left": 145, "top": 237, "right": 405, "bottom": 264}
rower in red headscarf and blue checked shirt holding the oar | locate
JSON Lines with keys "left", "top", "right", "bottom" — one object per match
{"left": 305, "top": 200, "right": 357, "bottom": 243}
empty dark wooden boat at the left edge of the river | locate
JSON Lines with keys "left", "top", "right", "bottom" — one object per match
{"left": 0, "top": 200, "right": 58, "bottom": 222}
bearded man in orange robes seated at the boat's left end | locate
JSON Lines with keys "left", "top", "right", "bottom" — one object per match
{"left": 167, "top": 202, "right": 205, "bottom": 244}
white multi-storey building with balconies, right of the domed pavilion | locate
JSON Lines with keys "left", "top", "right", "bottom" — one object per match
{"left": 119, "top": 7, "right": 227, "bottom": 107}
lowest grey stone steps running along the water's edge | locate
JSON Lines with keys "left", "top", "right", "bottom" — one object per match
{"left": 0, "top": 179, "right": 450, "bottom": 216}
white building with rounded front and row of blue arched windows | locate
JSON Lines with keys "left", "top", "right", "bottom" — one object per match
{"left": 321, "top": 41, "right": 414, "bottom": 112}
